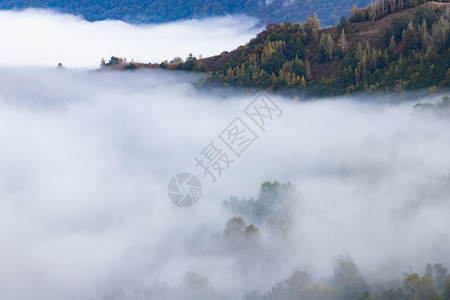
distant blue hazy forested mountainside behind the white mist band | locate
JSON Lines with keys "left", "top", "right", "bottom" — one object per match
{"left": 0, "top": 0, "right": 370, "bottom": 26}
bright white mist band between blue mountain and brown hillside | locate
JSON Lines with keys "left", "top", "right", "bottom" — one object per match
{"left": 0, "top": 9, "right": 261, "bottom": 69}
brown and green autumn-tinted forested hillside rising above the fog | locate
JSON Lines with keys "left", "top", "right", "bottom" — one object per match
{"left": 161, "top": 0, "right": 450, "bottom": 95}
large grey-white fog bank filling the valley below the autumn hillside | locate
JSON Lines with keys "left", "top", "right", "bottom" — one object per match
{"left": 0, "top": 67, "right": 450, "bottom": 300}
